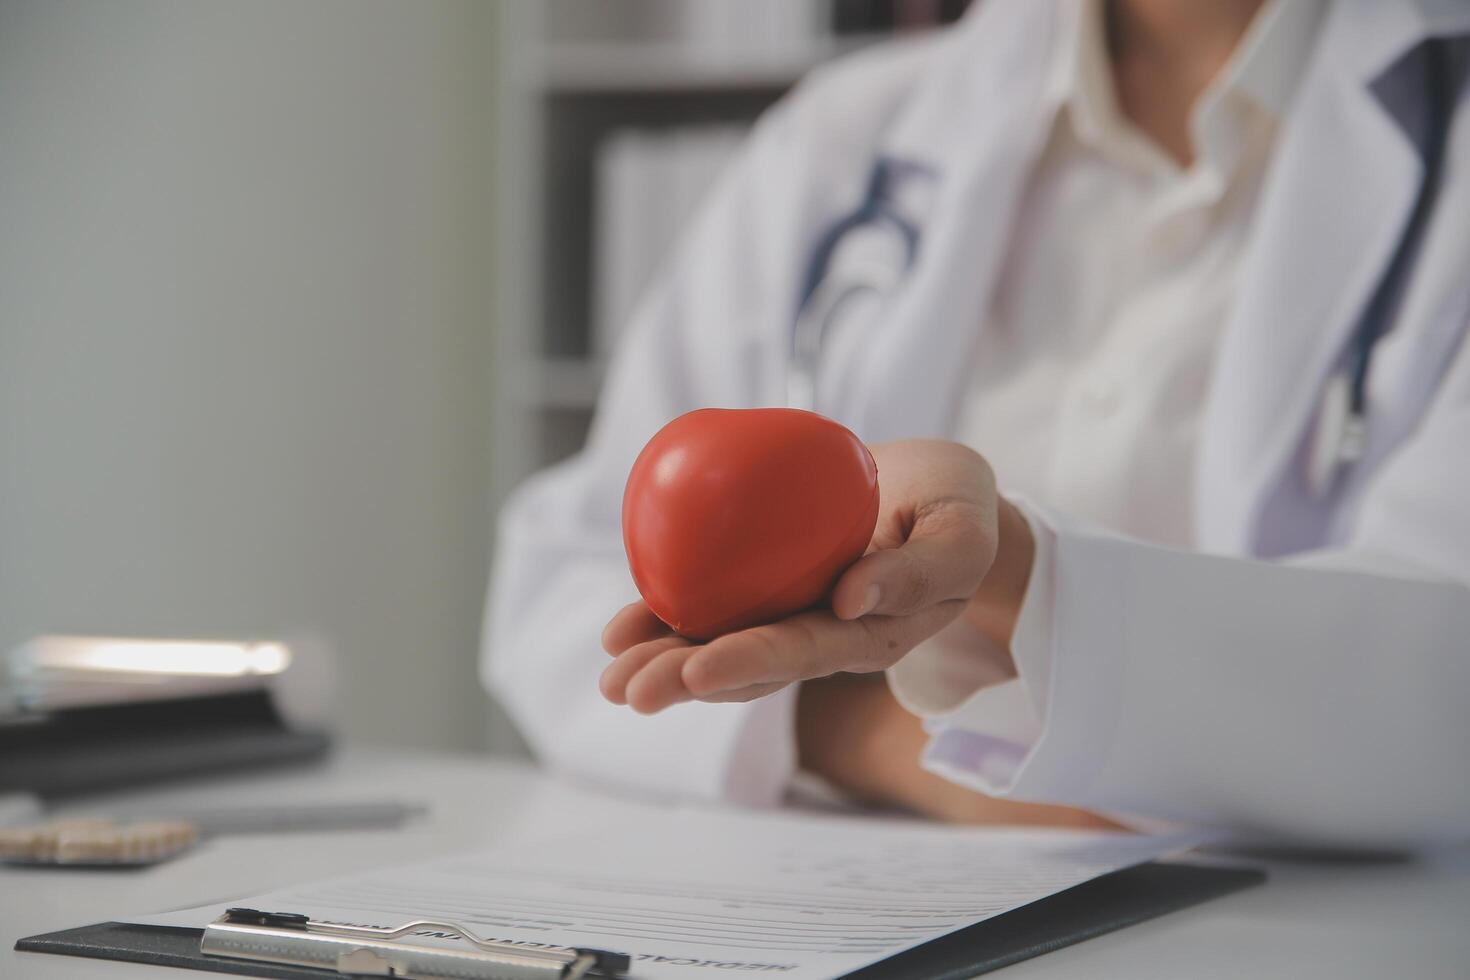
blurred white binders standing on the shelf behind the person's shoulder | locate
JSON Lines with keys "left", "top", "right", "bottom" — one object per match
{"left": 591, "top": 123, "right": 748, "bottom": 357}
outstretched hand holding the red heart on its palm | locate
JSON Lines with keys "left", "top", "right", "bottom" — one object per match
{"left": 601, "top": 439, "right": 1033, "bottom": 714}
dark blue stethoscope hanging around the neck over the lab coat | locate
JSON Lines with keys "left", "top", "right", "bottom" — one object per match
{"left": 786, "top": 38, "right": 1455, "bottom": 498}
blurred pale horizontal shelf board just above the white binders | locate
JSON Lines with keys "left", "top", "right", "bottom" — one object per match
{"left": 541, "top": 34, "right": 888, "bottom": 96}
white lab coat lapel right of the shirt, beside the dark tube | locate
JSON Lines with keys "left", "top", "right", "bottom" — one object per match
{"left": 1195, "top": 1, "right": 1452, "bottom": 557}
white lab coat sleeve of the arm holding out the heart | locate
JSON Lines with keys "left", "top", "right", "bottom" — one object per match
{"left": 899, "top": 357, "right": 1470, "bottom": 845}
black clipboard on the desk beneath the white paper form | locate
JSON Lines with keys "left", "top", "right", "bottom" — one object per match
{"left": 15, "top": 861, "right": 1266, "bottom": 980}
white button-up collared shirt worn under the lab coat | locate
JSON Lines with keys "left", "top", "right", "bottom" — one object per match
{"left": 889, "top": 0, "right": 1322, "bottom": 792}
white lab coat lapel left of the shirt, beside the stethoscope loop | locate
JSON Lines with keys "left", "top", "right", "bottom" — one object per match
{"left": 847, "top": 0, "right": 1058, "bottom": 441}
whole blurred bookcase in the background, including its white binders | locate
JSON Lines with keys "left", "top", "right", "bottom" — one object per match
{"left": 497, "top": 0, "right": 969, "bottom": 470}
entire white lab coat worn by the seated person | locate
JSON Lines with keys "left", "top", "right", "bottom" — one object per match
{"left": 484, "top": 0, "right": 1470, "bottom": 842}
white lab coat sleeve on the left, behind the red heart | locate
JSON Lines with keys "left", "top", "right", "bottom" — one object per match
{"left": 481, "top": 99, "right": 823, "bottom": 805}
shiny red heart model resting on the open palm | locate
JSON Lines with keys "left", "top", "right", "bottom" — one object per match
{"left": 623, "top": 408, "right": 878, "bottom": 639}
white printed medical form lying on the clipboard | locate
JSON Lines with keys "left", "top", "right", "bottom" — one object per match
{"left": 132, "top": 807, "right": 1192, "bottom": 979}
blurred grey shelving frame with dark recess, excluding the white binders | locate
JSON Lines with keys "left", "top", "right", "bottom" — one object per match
{"left": 493, "top": 9, "right": 892, "bottom": 476}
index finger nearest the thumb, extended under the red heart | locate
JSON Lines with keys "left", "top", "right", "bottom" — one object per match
{"left": 682, "top": 599, "right": 964, "bottom": 701}
